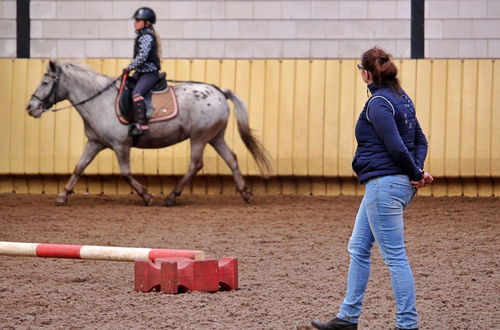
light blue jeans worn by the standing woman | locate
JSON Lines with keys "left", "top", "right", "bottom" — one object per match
{"left": 337, "top": 175, "right": 418, "bottom": 329}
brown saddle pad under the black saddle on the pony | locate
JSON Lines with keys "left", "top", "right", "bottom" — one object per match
{"left": 115, "top": 86, "right": 179, "bottom": 125}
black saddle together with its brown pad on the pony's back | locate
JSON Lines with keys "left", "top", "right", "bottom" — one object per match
{"left": 115, "top": 72, "right": 179, "bottom": 125}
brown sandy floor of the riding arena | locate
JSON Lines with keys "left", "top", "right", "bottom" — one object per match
{"left": 0, "top": 194, "right": 500, "bottom": 329}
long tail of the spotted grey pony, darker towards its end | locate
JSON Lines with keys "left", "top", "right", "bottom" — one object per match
{"left": 222, "top": 89, "right": 272, "bottom": 177}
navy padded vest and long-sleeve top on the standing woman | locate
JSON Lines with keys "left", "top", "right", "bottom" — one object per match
{"left": 353, "top": 84, "right": 427, "bottom": 183}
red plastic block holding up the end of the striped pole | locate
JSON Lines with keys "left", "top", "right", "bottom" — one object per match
{"left": 134, "top": 257, "right": 238, "bottom": 293}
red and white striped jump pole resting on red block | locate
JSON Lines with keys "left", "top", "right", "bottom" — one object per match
{"left": 0, "top": 242, "right": 205, "bottom": 261}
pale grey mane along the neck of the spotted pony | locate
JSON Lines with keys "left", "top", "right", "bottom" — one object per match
{"left": 59, "top": 61, "right": 112, "bottom": 93}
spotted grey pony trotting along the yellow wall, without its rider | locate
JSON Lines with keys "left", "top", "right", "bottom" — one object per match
{"left": 26, "top": 60, "right": 271, "bottom": 206}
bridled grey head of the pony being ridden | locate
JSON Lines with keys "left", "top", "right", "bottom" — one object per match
{"left": 26, "top": 60, "right": 63, "bottom": 118}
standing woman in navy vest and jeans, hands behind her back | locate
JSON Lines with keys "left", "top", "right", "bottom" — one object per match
{"left": 311, "top": 47, "right": 433, "bottom": 330}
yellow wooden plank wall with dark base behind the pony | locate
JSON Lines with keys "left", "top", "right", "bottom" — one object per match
{"left": 0, "top": 59, "right": 500, "bottom": 196}
